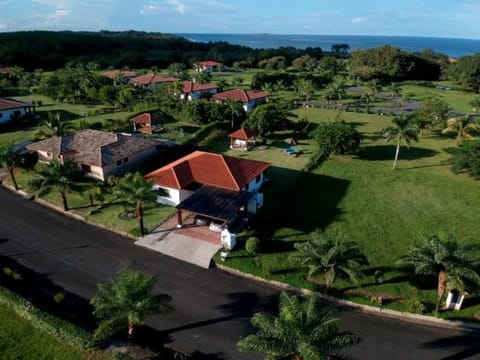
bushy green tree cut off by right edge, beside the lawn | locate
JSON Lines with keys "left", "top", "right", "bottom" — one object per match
{"left": 451, "top": 141, "right": 480, "bottom": 179}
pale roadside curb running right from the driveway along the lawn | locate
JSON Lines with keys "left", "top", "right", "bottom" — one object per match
{"left": 215, "top": 263, "right": 480, "bottom": 333}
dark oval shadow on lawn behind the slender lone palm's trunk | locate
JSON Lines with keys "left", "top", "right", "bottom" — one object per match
{"left": 358, "top": 145, "right": 439, "bottom": 161}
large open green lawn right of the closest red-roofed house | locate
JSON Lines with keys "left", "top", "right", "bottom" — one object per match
{"left": 216, "top": 105, "right": 480, "bottom": 319}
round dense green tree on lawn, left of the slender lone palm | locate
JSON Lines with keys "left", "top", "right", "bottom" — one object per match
{"left": 312, "top": 120, "right": 362, "bottom": 157}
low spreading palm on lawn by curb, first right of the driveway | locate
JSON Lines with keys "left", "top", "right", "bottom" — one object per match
{"left": 291, "top": 230, "right": 368, "bottom": 291}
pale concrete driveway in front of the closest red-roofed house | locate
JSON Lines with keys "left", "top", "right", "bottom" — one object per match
{"left": 135, "top": 231, "right": 221, "bottom": 269}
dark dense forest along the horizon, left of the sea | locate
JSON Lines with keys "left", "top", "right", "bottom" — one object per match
{"left": 0, "top": 31, "right": 323, "bottom": 71}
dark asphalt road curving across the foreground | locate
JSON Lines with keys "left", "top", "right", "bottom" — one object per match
{"left": 0, "top": 188, "right": 480, "bottom": 360}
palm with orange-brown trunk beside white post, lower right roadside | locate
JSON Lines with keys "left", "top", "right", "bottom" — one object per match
{"left": 400, "top": 235, "right": 480, "bottom": 312}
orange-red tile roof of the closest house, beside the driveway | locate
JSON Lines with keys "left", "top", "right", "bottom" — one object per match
{"left": 145, "top": 151, "right": 270, "bottom": 191}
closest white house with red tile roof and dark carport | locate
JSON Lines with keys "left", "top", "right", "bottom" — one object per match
{"left": 145, "top": 151, "right": 270, "bottom": 247}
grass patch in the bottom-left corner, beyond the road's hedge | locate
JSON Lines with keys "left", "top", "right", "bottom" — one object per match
{"left": 0, "top": 305, "right": 111, "bottom": 360}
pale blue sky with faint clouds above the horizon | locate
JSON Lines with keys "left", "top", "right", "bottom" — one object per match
{"left": 0, "top": 0, "right": 480, "bottom": 39}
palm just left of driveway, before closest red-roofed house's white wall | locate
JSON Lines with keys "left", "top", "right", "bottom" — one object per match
{"left": 113, "top": 173, "right": 164, "bottom": 236}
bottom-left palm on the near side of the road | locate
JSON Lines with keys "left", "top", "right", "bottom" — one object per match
{"left": 90, "top": 268, "right": 172, "bottom": 338}
